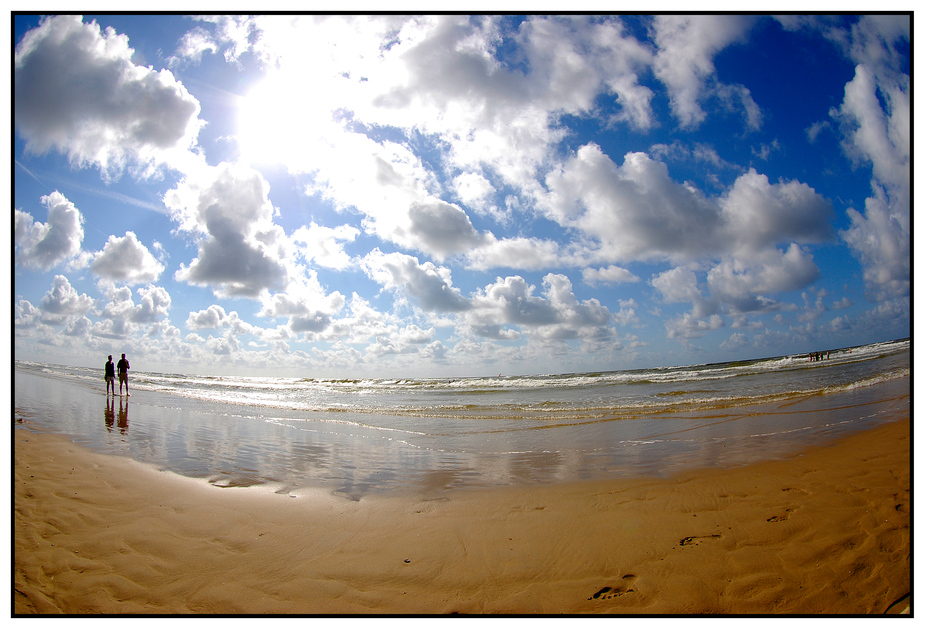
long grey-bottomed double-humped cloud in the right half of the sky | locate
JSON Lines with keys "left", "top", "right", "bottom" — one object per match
{"left": 543, "top": 144, "right": 833, "bottom": 272}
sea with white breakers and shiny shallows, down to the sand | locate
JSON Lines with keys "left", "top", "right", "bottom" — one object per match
{"left": 14, "top": 339, "right": 911, "bottom": 499}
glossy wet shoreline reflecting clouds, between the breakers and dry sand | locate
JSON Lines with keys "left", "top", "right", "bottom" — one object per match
{"left": 14, "top": 368, "right": 911, "bottom": 499}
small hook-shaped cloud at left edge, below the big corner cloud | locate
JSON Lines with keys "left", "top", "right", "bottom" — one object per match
{"left": 13, "top": 191, "right": 84, "bottom": 271}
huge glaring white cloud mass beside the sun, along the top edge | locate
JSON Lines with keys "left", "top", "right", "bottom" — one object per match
{"left": 218, "top": 16, "right": 654, "bottom": 223}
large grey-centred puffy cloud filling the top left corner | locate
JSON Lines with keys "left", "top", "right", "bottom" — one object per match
{"left": 13, "top": 15, "right": 201, "bottom": 177}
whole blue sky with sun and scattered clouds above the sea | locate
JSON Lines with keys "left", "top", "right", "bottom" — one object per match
{"left": 12, "top": 14, "right": 911, "bottom": 378}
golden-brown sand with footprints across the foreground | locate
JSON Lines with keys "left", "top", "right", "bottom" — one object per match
{"left": 13, "top": 418, "right": 911, "bottom": 615}
